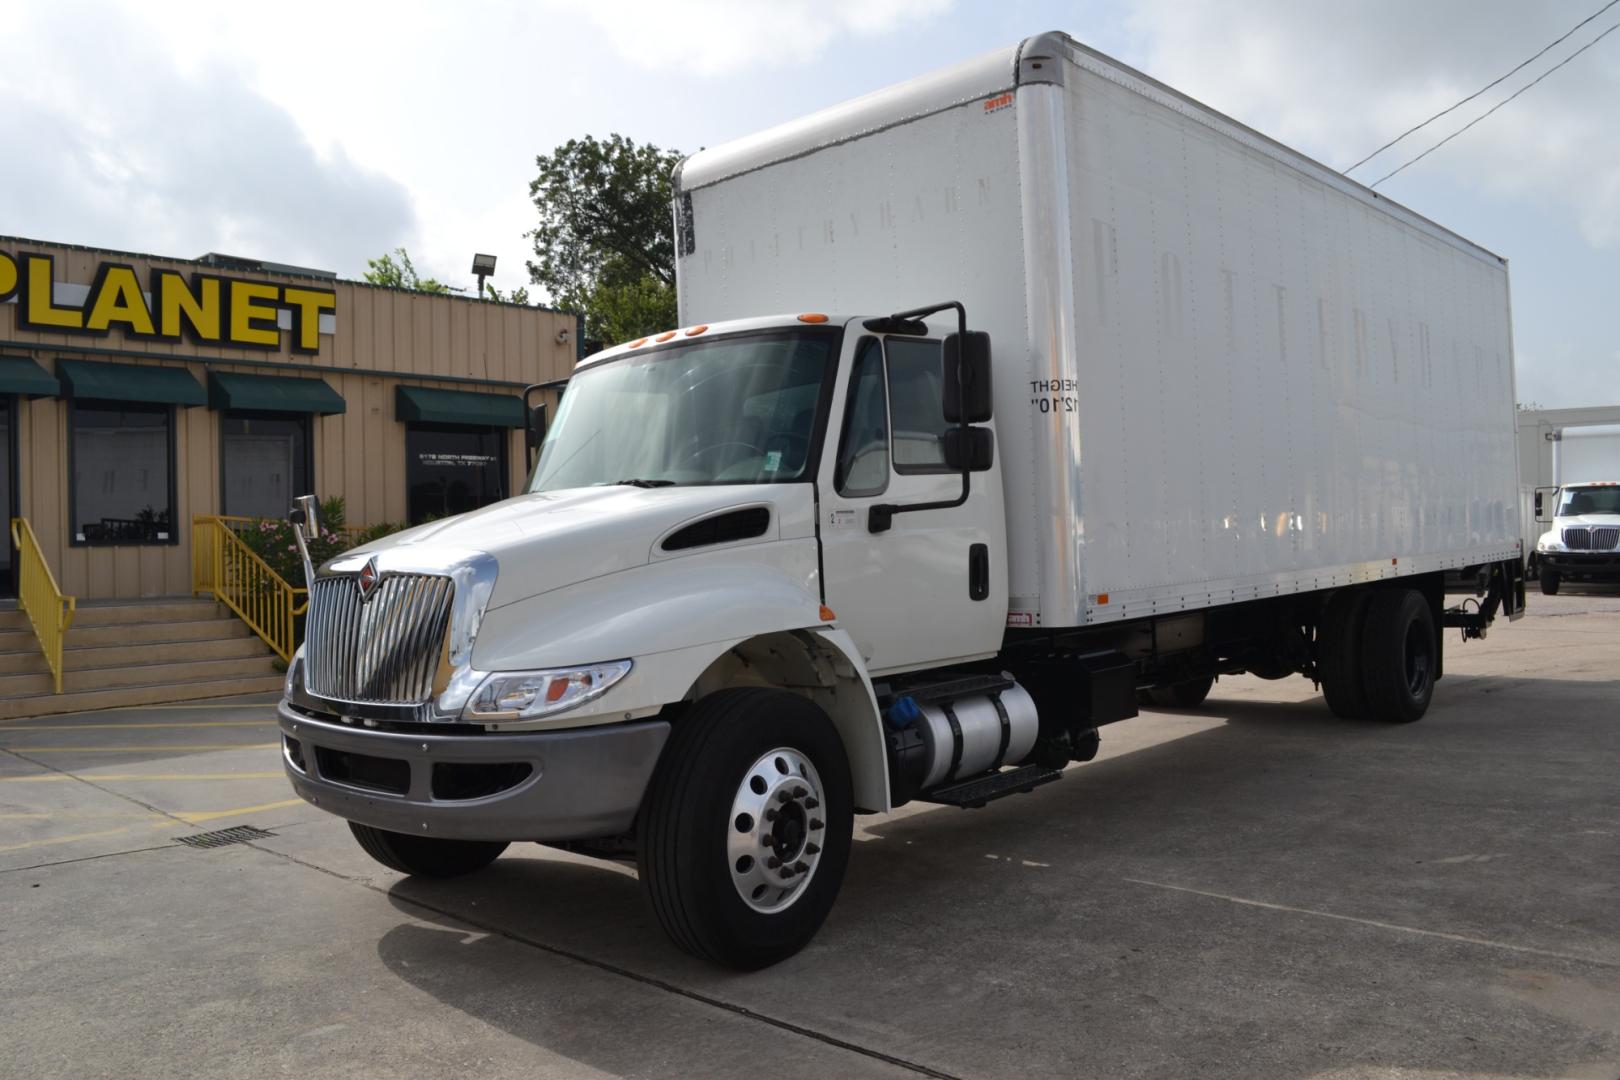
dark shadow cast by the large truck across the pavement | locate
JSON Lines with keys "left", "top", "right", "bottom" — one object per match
{"left": 367, "top": 675, "right": 1620, "bottom": 1075}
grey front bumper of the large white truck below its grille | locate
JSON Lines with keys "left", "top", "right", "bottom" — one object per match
{"left": 277, "top": 701, "right": 669, "bottom": 840}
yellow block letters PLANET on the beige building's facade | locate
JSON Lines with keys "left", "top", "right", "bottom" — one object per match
{"left": 0, "top": 251, "right": 337, "bottom": 355}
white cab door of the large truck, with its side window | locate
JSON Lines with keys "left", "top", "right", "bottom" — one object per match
{"left": 818, "top": 334, "right": 1008, "bottom": 672}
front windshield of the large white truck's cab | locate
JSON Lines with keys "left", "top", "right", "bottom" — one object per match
{"left": 530, "top": 330, "right": 839, "bottom": 491}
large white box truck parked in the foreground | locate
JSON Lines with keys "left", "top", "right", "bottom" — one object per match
{"left": 280, "top": 34, "right": 1524, "bottom": 968}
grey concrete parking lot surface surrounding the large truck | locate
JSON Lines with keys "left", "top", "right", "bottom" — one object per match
{"left": 0, "top": 586, "right": 1620, "bottom": 1080}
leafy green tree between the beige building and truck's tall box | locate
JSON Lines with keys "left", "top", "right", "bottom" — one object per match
{"left": 528, "top": 134, "right": 680, "bottom": 343}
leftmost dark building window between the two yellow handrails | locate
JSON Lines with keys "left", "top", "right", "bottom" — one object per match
{"left": 71, "top": 402, "right": 177, "bottom": 544}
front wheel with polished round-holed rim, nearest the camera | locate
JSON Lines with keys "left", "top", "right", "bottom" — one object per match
{"left": 637, "top": 688, "right": 854, "bottom": 970}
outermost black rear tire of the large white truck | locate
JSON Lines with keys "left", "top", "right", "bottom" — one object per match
{"left": 1361, "top": 589, "right": 1440, "bottom": 724}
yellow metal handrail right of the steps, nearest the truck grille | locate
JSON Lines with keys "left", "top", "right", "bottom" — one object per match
{"left": 191, "top": 513, "right": 309, "bottom": 662}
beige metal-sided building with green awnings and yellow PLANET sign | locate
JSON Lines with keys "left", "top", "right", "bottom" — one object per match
{"left": 0, "top": 236, "right": 580, "bottom": 601}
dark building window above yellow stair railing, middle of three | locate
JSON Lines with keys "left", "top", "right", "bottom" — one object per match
{"left": 219, "top": 410, "right": 314, "bottom": 518}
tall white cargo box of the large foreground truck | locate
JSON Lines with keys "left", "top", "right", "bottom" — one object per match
{"left": 676, "top": 34, "right": 1520, "bottom": 628}
